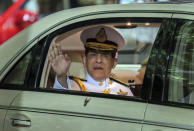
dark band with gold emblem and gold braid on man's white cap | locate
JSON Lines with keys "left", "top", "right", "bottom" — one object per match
{"left": 85, "top": 28, "right": 118, "bottom": 51}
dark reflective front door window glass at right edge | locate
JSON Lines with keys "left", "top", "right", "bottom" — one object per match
{"left": 168, "top": 20, "right": 194, "bottom": 104}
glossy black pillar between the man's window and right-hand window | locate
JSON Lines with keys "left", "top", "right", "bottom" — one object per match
{"left": 146, "top": 19, "right": 175, "bottom": 101}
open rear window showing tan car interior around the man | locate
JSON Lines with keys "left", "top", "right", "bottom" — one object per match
{"left": 42, "top": 19, "right": 162, "bottom": 96}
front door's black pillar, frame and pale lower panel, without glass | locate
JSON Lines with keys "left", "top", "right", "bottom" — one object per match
{"left": 142, "top": 12, "right": 194, "bottom": 131}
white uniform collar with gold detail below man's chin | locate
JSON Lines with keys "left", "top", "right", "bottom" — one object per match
{"left": 86, "top": 73, "right": 110, "bottom": 87}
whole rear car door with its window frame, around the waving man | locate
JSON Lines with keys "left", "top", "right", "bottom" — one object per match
{"left": 0, "top": 5, "right": 171, "bottom": 131}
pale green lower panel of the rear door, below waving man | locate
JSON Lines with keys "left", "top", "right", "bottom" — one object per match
{"left": 2, "top": 18, "right": 147, "bottom": 131}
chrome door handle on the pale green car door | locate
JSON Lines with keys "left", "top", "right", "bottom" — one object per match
{"left": 12, "top": 119, "right": 31, "bottom": 127}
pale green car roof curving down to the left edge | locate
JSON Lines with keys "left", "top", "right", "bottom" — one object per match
{"left": 0, "top": 2, "right": 194, "bottom": 74}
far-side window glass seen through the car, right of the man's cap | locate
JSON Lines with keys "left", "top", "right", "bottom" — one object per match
{"left": 118, "top": 25, "right": 160, "bottom": 64}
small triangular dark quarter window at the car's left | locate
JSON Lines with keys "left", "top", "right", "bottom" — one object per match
{"left": 1, "top": 41, "right": 42, "bottom": 87}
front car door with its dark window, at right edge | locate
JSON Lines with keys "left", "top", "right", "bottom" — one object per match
{"left": 143, "top": 13, "right": 194, "bottom": 131}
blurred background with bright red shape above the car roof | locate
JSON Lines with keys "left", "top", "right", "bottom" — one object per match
{"left": 0, "top": 0, "right": 168, "bottom": 45}
